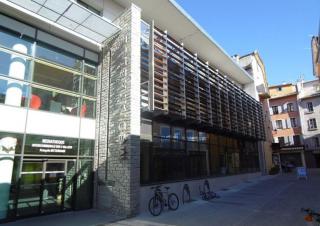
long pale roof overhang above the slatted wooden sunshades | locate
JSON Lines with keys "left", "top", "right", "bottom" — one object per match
{"left": 115, "top": 0, "right": 253, "bottom": 85}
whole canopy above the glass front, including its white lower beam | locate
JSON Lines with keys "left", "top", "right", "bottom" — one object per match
{"left": 0, "top": 0, "right": 120, "bottom": 51}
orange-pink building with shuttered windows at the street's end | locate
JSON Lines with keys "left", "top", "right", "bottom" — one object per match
{"left": 269, "top": 84, "right": 306, "bottom": 166}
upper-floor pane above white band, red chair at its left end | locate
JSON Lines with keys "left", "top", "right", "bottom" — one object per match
{"left": 30, "top": 87, "right": 79, "bottom": 115}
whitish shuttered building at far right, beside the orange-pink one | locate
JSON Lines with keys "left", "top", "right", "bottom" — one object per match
{"left": 297, "top": 80, "right": 320, "bottom": 168}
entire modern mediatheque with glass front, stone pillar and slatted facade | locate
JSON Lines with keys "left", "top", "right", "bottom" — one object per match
{"left": 0, "top": 0, "right": 265, "bottom": 221}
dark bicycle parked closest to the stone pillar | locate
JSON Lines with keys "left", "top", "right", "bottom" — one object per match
{"left": 148, "top": 185, "right": 179, "bottom": 216}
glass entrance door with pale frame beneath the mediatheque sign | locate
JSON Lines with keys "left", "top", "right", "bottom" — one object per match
{"left": 17, "top": 159, "right": 76, "bottom": 217}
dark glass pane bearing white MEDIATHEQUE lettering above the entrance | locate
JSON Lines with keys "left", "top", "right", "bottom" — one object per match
{"left": 24, "top": 135, "right": 78, "bottom": 155}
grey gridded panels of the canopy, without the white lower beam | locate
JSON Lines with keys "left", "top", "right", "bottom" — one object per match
{"left": 8, "top": 0, "right": 120, "bottom": 43}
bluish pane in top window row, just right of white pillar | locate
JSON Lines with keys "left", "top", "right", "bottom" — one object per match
{"left": 36, "top": 43, "right": 82, "bottom": 71}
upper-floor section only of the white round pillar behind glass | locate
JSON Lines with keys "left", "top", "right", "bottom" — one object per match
{"left": 5, "top": 44, "right": 28, "bottom": 106}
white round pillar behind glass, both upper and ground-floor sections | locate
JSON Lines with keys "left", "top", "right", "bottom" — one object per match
{"left": 0, "top": 43, "right": 28, "bottom": 219}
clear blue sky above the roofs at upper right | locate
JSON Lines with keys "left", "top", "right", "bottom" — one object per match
{"left": 176, "top": 0, "right": 320, "bottom": 85}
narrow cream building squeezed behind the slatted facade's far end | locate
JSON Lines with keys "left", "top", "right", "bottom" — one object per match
{"left": 238, "top": 51, "right": 273, "bottom": 173}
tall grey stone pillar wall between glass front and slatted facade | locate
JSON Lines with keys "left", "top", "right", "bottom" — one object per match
{"left": 95, "top": 5, "right": 141, "bottom": 217}
